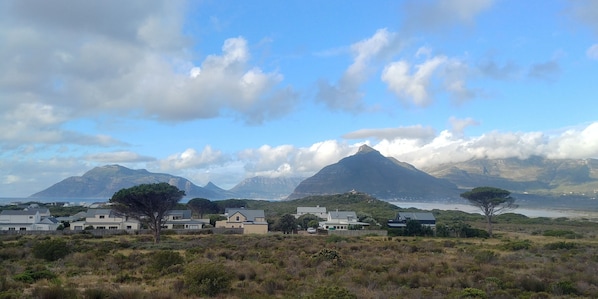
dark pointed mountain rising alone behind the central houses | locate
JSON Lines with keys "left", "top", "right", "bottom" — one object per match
{"left": 288, "top": 145, "right": 459, "bottom": 200}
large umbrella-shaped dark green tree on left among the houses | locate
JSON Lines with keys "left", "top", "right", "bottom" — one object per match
{"left": 110, "top": 183, "right": 185, "bottom": 243}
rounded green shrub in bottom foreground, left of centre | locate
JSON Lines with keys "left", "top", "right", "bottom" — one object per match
{"left": 185, "top": 263, "right": 233, "bottom": 296}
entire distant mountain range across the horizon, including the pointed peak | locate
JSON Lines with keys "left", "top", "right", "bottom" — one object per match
{"left": 31, "top": 145, "right": 598, "bottom": 201}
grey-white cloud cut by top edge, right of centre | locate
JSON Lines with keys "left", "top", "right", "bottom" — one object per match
{"left": 402, "top": 0, "right": 495, "bottom": 31}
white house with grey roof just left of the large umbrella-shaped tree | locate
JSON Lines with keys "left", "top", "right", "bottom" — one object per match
{"left": 71, "top": 209, "right": 140, "bottom": 230}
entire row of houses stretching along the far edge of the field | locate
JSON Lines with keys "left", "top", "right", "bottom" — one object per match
{"left": 0, "top": 205, "right": 436, "bottom": 234}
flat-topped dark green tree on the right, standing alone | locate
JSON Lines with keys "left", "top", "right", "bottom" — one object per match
{"left": 461, "top": 187, "right": 517, "bottom": 238}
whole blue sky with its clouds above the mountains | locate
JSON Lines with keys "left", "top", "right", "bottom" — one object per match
{"left": 0, "top": 0, "right": 598, "bottom": 197}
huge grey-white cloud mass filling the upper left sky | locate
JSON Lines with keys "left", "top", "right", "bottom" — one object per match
{"left": 0, "top": 0, "right": 298, "bottom": 152}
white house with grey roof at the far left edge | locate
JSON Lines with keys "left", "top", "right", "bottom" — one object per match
{"left": 0, "top": 209, "right": 60, "bottom": 231}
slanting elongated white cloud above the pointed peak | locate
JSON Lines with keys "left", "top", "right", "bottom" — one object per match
{"left": 316, "top": 29, "right": 401, "bottom": 112}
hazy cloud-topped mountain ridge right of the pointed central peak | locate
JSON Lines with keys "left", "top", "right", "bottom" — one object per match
{"left": 425, "top": 156, "right": 598, "bottom": 197}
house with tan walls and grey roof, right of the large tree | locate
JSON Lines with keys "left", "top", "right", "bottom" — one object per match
{"left": 216, "top": 209, "right": 268, "bottom": 234}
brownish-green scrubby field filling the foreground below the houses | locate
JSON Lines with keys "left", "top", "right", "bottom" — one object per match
{"left": 0, "top": 223, "right": 598, "bottom": 298}
